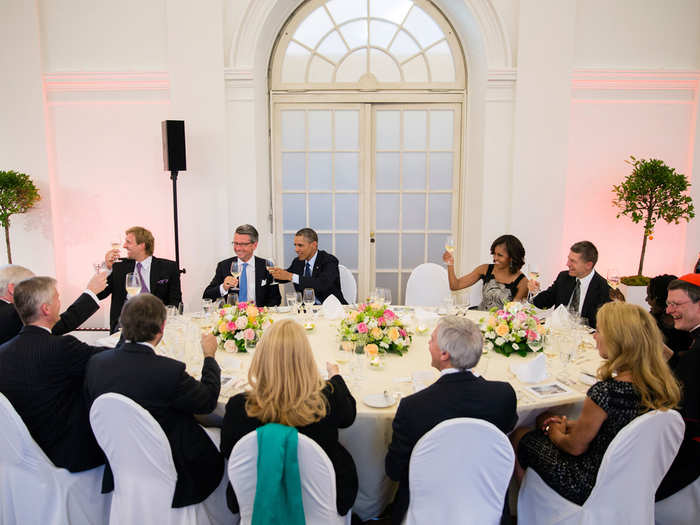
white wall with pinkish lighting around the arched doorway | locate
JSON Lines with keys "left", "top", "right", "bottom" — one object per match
{"left": 0, "top": 0, "right": 700, "bottom": 324}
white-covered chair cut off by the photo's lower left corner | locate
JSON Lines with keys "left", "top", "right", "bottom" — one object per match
{"left": 0, "top": 394, "right": 111, "bottom": 525}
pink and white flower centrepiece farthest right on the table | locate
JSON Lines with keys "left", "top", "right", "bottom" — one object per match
{"left": 479, "top": 302, "right": 545, "bottom": 357}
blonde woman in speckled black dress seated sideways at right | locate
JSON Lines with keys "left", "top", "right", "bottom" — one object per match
{"left": 512, "top": 302, "right": 680, "bottom": 505}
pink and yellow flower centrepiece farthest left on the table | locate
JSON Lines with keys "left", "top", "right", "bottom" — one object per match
{"left": 213, "top": 301, "right": 272, "bottom": 353}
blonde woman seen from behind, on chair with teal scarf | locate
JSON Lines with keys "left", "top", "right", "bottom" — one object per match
{"left": 221, "top": 319, "right": 358, "bottom": 516}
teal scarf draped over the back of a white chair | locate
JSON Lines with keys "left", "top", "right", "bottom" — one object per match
{"left": 252, "top": 423, "right": 306, "bottom": 525}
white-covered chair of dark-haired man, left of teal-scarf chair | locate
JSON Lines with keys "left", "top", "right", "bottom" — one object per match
{"left": 90, "top": 393, "right": 232, "bottom": 525}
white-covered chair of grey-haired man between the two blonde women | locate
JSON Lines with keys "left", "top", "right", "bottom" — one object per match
{"left": 404, "top": 417, "right": 515, "bottom": 525}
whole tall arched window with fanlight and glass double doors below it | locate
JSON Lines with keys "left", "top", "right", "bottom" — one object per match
{"left": 270, "top": 0, "right": 466, "bottom": 303}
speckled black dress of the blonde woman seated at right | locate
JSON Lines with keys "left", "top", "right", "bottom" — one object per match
{"left": 518, "top": 379, "right": 641, "bottom": 505}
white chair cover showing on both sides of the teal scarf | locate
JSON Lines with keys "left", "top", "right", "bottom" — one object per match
{"left": 228, "top": 430, "right": 351, "bottom": 525}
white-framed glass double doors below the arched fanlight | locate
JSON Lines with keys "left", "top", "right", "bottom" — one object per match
{"left": 272, "top": 103, "right": 461, "bottom": 304}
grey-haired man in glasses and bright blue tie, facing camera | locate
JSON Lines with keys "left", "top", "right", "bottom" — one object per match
{"left": 202, "top": 224, "right": 282, "bottom": 306}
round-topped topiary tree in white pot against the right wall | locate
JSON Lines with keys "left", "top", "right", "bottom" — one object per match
{"left": 613, "top": 156, "right": 695, "bottom": 305}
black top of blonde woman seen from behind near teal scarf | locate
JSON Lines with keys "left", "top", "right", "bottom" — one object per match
{"left": 221, "top": 375, "right": 358, "bottom": 516}
